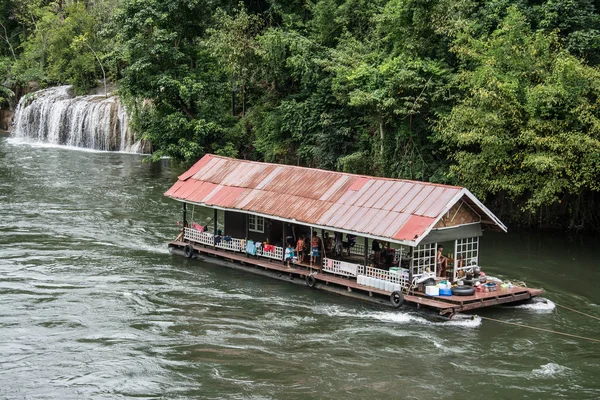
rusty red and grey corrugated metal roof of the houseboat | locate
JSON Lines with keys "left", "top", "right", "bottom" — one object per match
{"left": 165, "top": 154, "right": 506, "bottom": 245}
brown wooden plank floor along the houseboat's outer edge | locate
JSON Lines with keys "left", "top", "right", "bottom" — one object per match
{"left": 171, "top": 241, "right": 543, "bottom": 311}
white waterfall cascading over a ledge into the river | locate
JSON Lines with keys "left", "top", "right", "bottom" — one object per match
{"left": 13, "top": 86, "right": 149, "bottom": 153}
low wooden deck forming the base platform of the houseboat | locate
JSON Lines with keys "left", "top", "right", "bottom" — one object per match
{"left": 169, "top": 241, "right": 543, "bottom": 316}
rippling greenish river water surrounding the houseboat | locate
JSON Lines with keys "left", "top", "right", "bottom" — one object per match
{"left": 0, "top": 136, "right": 600, "bottom": 399}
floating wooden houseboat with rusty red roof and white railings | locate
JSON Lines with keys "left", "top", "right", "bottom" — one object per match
{"left": 165, "top": 154, "right": 543, "bottom": 318}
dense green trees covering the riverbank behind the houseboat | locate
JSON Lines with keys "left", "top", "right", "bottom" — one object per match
{"left": 0, "top": 0, "right": 600, "bottom": 229}
